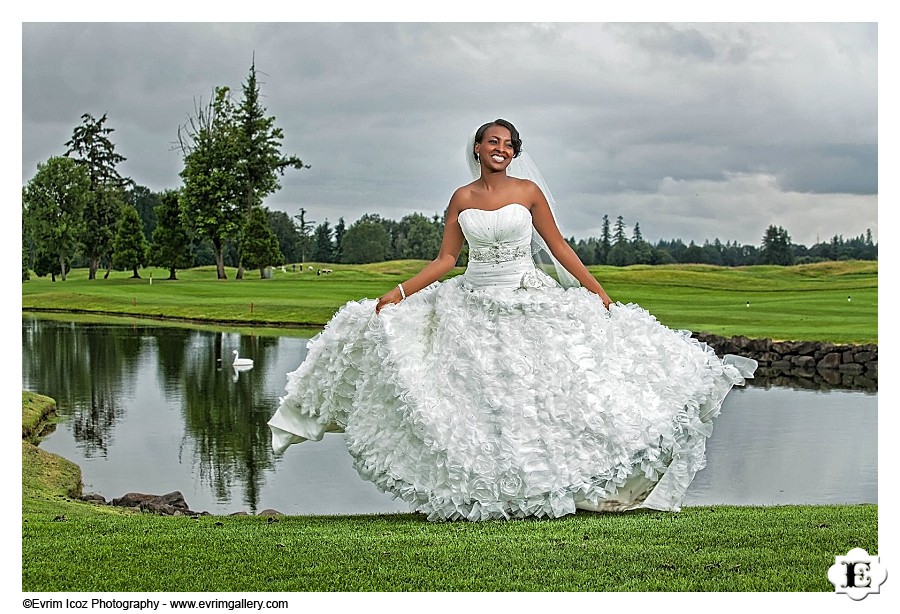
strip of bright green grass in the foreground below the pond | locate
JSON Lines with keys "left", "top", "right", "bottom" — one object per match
{"left": 22, "top": 503, "right": 878, "bottom": 592}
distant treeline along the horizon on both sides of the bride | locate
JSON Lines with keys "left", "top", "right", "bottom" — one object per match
{"left": 125, "top": 188, "right": 878, "bottom": 266}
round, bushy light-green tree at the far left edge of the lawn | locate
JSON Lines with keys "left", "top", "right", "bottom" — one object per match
{"left": 22, "top": 157, "right": 91, "bottom": 281}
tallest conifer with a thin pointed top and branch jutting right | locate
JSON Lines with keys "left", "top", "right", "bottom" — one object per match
{"left": 235, "top": 60, "right": 309, "bottom": 278}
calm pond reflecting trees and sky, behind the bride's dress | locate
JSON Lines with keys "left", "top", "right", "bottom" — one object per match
{"left": 22, "top": 316, "right": 878, "bottom": 514}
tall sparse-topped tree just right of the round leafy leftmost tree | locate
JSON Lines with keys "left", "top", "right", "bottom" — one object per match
{"left": 65, "top": 113, "right": 131, "bottom": 279}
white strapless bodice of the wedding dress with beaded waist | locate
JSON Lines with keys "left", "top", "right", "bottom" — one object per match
{"left": 459, "top": 203, "right": 534, "bottom": 289}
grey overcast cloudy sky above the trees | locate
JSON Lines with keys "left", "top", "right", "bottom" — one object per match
{"left": 21, "top": 22, "right": 879, "bottom": 245}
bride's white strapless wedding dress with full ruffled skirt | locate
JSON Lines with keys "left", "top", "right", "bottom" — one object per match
{"left": 269, "top": 204, "right": 756, "bottom": 520}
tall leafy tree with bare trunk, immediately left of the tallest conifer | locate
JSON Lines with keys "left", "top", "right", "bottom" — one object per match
{"left": 178, "top": 87, "right": 246, "bottom": 279}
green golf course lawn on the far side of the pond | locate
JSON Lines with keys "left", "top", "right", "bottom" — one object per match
{"left": 22, "top": 261, "right": 878, "bottom": 343}
